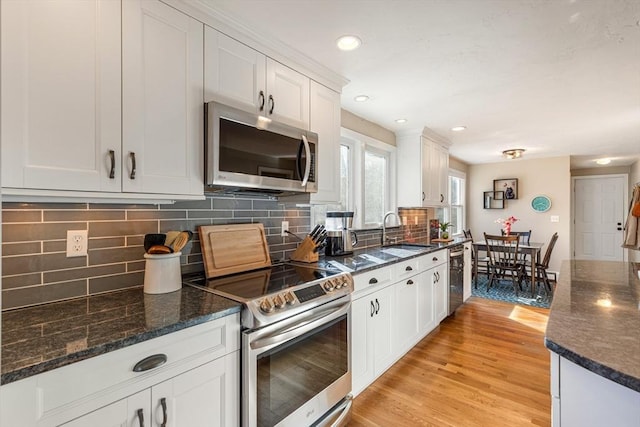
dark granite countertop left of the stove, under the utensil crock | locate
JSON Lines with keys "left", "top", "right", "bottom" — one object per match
{"left": 1, "top": 286, "right": 240, "bottom": 384}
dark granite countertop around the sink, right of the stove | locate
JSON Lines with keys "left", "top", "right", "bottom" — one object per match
{"left": 317, "top": 237, "right": 470, "bottom": 274}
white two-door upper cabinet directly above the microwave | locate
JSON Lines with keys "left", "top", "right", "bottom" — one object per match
{"left": 205, "top": 27, "right": 310, "bottom": 129}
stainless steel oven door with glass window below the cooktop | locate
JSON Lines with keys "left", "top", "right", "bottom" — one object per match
{"left": 242, "top": 296, "right": 351, "bottom": 427}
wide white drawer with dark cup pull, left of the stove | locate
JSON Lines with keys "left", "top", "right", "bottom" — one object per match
{"left": 34, "top": 314, "right": 240, "bottom": 425}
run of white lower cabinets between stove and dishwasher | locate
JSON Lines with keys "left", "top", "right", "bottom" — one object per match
{"left": 351, "top": 250, "right": 449, "bottom": 395}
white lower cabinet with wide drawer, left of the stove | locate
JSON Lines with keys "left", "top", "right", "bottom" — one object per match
{"left": 0, "top": 314, "right": 240, "bottom": 427}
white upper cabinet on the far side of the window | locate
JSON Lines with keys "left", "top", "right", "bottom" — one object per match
{"left": 397, "top": 128, "right": 450, "bottom": 207}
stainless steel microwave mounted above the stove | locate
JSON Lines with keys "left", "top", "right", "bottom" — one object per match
{"left": 205, "top": 101, "right": 318, "bottom": 193}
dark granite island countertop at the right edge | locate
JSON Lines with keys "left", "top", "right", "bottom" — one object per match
{"left": 545, "top": 261, "right": 640, "bottom": 392}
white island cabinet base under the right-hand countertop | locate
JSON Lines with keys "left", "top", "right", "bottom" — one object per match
{"left": 551, "top": 352, "right": 640, "bottom": 427}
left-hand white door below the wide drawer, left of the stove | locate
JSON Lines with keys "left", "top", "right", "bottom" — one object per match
{"left": 62, "top": 389, "right": 151, "bottom": 427}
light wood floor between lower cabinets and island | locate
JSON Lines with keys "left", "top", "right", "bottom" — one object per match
{"left": 349, "top": 297, "right": 551, "bottom": 427}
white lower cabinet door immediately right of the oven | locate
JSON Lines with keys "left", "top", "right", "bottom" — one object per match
{"left": 351, "top": 296, "right": 375, "bottom": 395}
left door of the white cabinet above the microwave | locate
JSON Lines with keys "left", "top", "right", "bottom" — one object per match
{"left": 204, "top": 26, "right": 266, "bottom": 109}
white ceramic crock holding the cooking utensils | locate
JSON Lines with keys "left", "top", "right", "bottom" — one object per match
{"left": 144, "top": 252, "right": 182, "bottom": 294}
